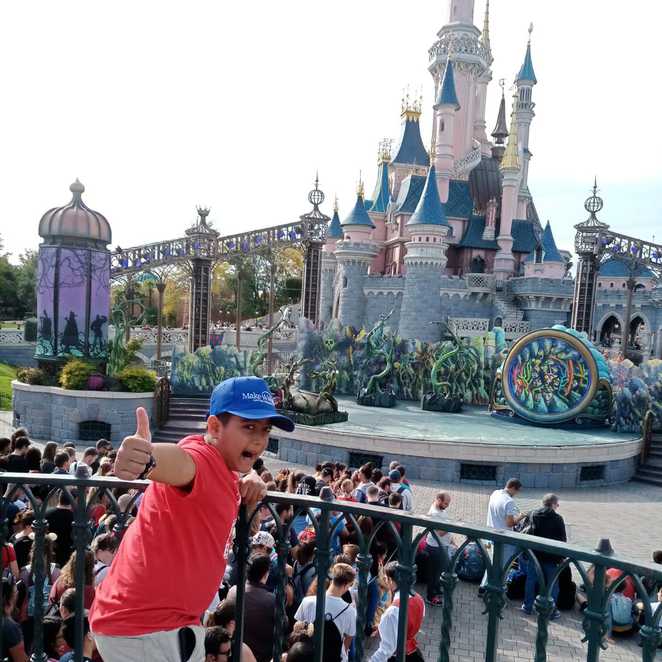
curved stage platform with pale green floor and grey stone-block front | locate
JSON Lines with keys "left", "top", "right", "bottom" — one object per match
{"left": 272, "top": 397, "right": 642, "bottom": 489}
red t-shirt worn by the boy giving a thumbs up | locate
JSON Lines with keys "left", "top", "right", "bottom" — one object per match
{"left": 90, "top": 435, "right": 241, "bottom": 637}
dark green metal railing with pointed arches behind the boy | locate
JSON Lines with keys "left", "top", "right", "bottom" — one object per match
{"left": 0, "top": 473, "right": 662, "bottom": 662}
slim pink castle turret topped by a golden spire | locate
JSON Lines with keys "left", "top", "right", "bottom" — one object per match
{"left": 494, "top": 96, "right": 520, "bottom": 282}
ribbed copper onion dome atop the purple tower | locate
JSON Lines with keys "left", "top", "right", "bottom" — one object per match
{"left": 39, "top": 179, "right": 112, "bottom": 248}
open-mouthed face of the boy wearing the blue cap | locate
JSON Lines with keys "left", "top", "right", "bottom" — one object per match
{"left": 207, "top": 415, "right": 272, "bottom": 474}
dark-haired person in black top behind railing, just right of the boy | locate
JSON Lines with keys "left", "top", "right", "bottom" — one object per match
{"left": 226, "top": 554, "right": 287, "bottom": 662}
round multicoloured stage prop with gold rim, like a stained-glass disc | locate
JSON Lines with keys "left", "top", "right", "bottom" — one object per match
{"left": 501, "top": 329, "right": 600, "bottom": 425}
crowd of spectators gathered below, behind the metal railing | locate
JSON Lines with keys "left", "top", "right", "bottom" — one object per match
{"left": 0, "top": 429, "right": 662, "bottom": 662}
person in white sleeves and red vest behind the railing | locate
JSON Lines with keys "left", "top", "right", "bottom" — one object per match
{"left": 370, "top": 561, "right": 425, "bottom": 662}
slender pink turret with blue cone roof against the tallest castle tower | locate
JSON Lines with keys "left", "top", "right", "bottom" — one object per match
{"left": 434, "top": 58, "right": 460, "bottom": 202}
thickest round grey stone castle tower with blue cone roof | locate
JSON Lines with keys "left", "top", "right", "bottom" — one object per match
{"left": 398, "top": 165, "right": 449, "bottom": 342}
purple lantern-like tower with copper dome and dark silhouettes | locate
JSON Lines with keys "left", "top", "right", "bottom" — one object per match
{"left": 35, "top": 180, "right": 111, "bottom": 364}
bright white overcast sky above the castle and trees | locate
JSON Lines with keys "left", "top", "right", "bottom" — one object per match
{"left": 0, "top": 0, "right": 662, "bottom": 264}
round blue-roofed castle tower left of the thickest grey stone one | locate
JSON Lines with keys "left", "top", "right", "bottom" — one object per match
{"left": 335, "top": 183, "right": 379, "bottom": 329}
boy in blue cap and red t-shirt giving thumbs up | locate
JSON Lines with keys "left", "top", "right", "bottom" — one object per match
{"left": 90, "top": 377, "right": 294, "bottom": 662}
